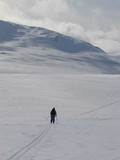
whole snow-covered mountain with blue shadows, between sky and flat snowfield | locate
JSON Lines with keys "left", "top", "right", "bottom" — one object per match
{"left": 0, "top": 21, "right": 120, "bottom": 74}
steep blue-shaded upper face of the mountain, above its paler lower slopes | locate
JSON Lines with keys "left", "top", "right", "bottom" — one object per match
{"left": 0, "top": 21, "right": 104, "bottom": 53}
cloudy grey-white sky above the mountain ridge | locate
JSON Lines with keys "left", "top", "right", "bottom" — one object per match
{"left": 0, "top": 0, "right": 120, "bottom": 54}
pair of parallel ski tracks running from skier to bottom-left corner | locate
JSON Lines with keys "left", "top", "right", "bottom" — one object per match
{"left": 7, "top": 125, "right": 52, "bottom": 160}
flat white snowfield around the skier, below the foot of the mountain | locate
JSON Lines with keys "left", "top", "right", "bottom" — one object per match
{"left": 0, "top": 73, "right": 120, "bottom": 160}
